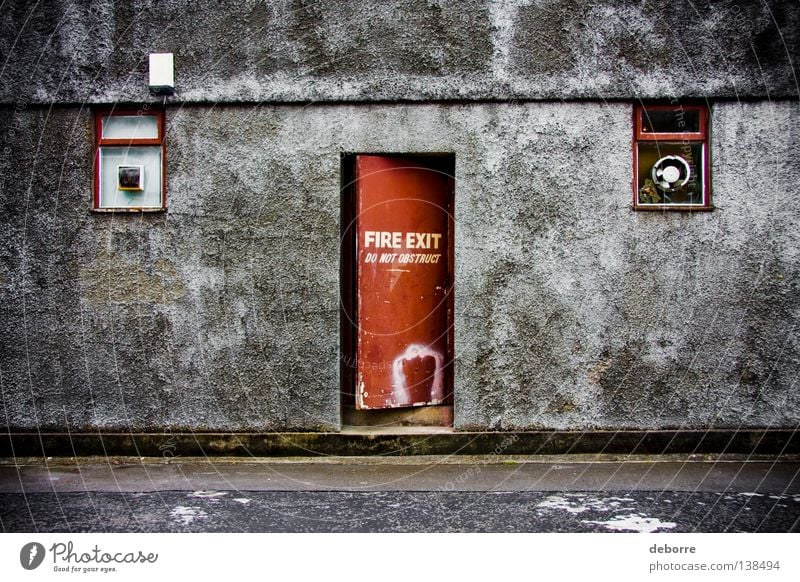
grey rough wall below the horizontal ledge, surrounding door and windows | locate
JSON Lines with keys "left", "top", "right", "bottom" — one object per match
{"left": 0, "top": 101, "right": 800, "bottom": 430}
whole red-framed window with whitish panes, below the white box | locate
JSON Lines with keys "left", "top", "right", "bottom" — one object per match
{"left": 93, "top": 109, "right": 166, "bottom": 212}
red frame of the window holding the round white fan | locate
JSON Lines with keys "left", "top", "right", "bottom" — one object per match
{"left": 632, "top": 104, "right": 714, "bottom": 211}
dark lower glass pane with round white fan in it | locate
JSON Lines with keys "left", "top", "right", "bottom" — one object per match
{"left": 636, "top": 142, "right": 704, "bottom": 204}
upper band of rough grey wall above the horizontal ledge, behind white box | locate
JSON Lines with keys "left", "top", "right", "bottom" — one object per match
{"left": 0, "top": 0, "right": 800, "bottom": 103}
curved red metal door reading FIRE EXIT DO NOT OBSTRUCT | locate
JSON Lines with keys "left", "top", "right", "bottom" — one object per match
{"left": 355, "top": 155, "right": 453, "bottom": 409}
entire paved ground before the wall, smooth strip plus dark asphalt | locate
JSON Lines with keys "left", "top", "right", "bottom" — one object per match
{"left": 0, "top": 455, "right": 800, "bottom": 533}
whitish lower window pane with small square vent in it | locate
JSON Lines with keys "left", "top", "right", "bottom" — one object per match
{"left": 99, "top": 146, "right": 161, "bottom": 208}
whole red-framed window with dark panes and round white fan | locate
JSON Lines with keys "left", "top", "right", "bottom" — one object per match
{"left": 633, "top": 104, "right": 712, "bottom": 210}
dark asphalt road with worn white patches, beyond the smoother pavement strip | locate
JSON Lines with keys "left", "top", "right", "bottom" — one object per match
{"left": 0, "top": 491, "right": 800, "bottom": 533}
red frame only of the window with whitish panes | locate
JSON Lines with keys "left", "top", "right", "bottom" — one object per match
{"left": 92, "top": 108, "right": 167, "bottom": 212}
